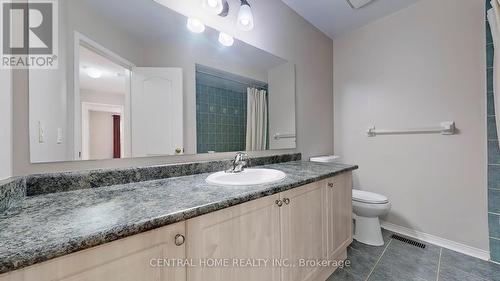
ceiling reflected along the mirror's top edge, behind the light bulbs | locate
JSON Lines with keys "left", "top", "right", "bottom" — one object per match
{"left": 82, "top": 0, "right": 286, "bottom": 70}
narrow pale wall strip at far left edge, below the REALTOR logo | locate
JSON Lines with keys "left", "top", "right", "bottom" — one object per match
{"left": 0, "top": 70, "right": 12, "bottom": 180}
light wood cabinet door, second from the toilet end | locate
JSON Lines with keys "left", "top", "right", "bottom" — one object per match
{"left": 280, "top": 182, "right": 326, "bottom": 281}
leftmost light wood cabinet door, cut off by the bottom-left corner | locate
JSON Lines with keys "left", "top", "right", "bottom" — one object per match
{"left": 0, "top": 222, "right": 186, "bottom": 281}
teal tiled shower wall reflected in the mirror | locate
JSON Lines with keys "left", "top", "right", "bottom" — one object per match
{"left": 196, "top": 82, "right": 247, "bottom": 153}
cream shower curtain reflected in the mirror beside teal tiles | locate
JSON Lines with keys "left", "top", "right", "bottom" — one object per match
{"left": 246, "top": 88, "right": 267, "bottom": 151}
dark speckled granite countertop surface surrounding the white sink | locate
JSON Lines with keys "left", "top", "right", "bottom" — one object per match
{"left": 0, "top": 161, "right": 357, "bottom": 273}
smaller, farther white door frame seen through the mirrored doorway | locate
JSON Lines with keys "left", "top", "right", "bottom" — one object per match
{"left": 81, "top": 102, "right": 124, "bottom": 160}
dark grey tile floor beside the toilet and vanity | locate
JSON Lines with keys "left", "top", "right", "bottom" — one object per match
{"left": 327, "top": 231, "right": 500, "bottom": 281}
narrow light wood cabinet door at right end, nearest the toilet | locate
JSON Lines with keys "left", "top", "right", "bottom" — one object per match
{"left": 325, "top": 173, "right": 352, "bottom": 259}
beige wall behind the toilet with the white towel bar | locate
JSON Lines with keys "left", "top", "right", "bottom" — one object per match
{"left": 334, "top": 0, "right": 488, "bottom": 250}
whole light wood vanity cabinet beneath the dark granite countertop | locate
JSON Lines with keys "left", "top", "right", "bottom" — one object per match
{"left": 0, "top": 172, "right": 352, "bottom": 281}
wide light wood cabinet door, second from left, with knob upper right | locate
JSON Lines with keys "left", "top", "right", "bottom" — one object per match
{"left": 187, "top": 195, "right": 280, "bottom": 281}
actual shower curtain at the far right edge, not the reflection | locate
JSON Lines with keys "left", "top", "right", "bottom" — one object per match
{"left": 488, "top": 0, "right": 500, "bottom": 145}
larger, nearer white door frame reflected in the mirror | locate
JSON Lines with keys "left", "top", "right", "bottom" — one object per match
{"left": 73, "top": 31, "right": 135, "bottom": 160}
